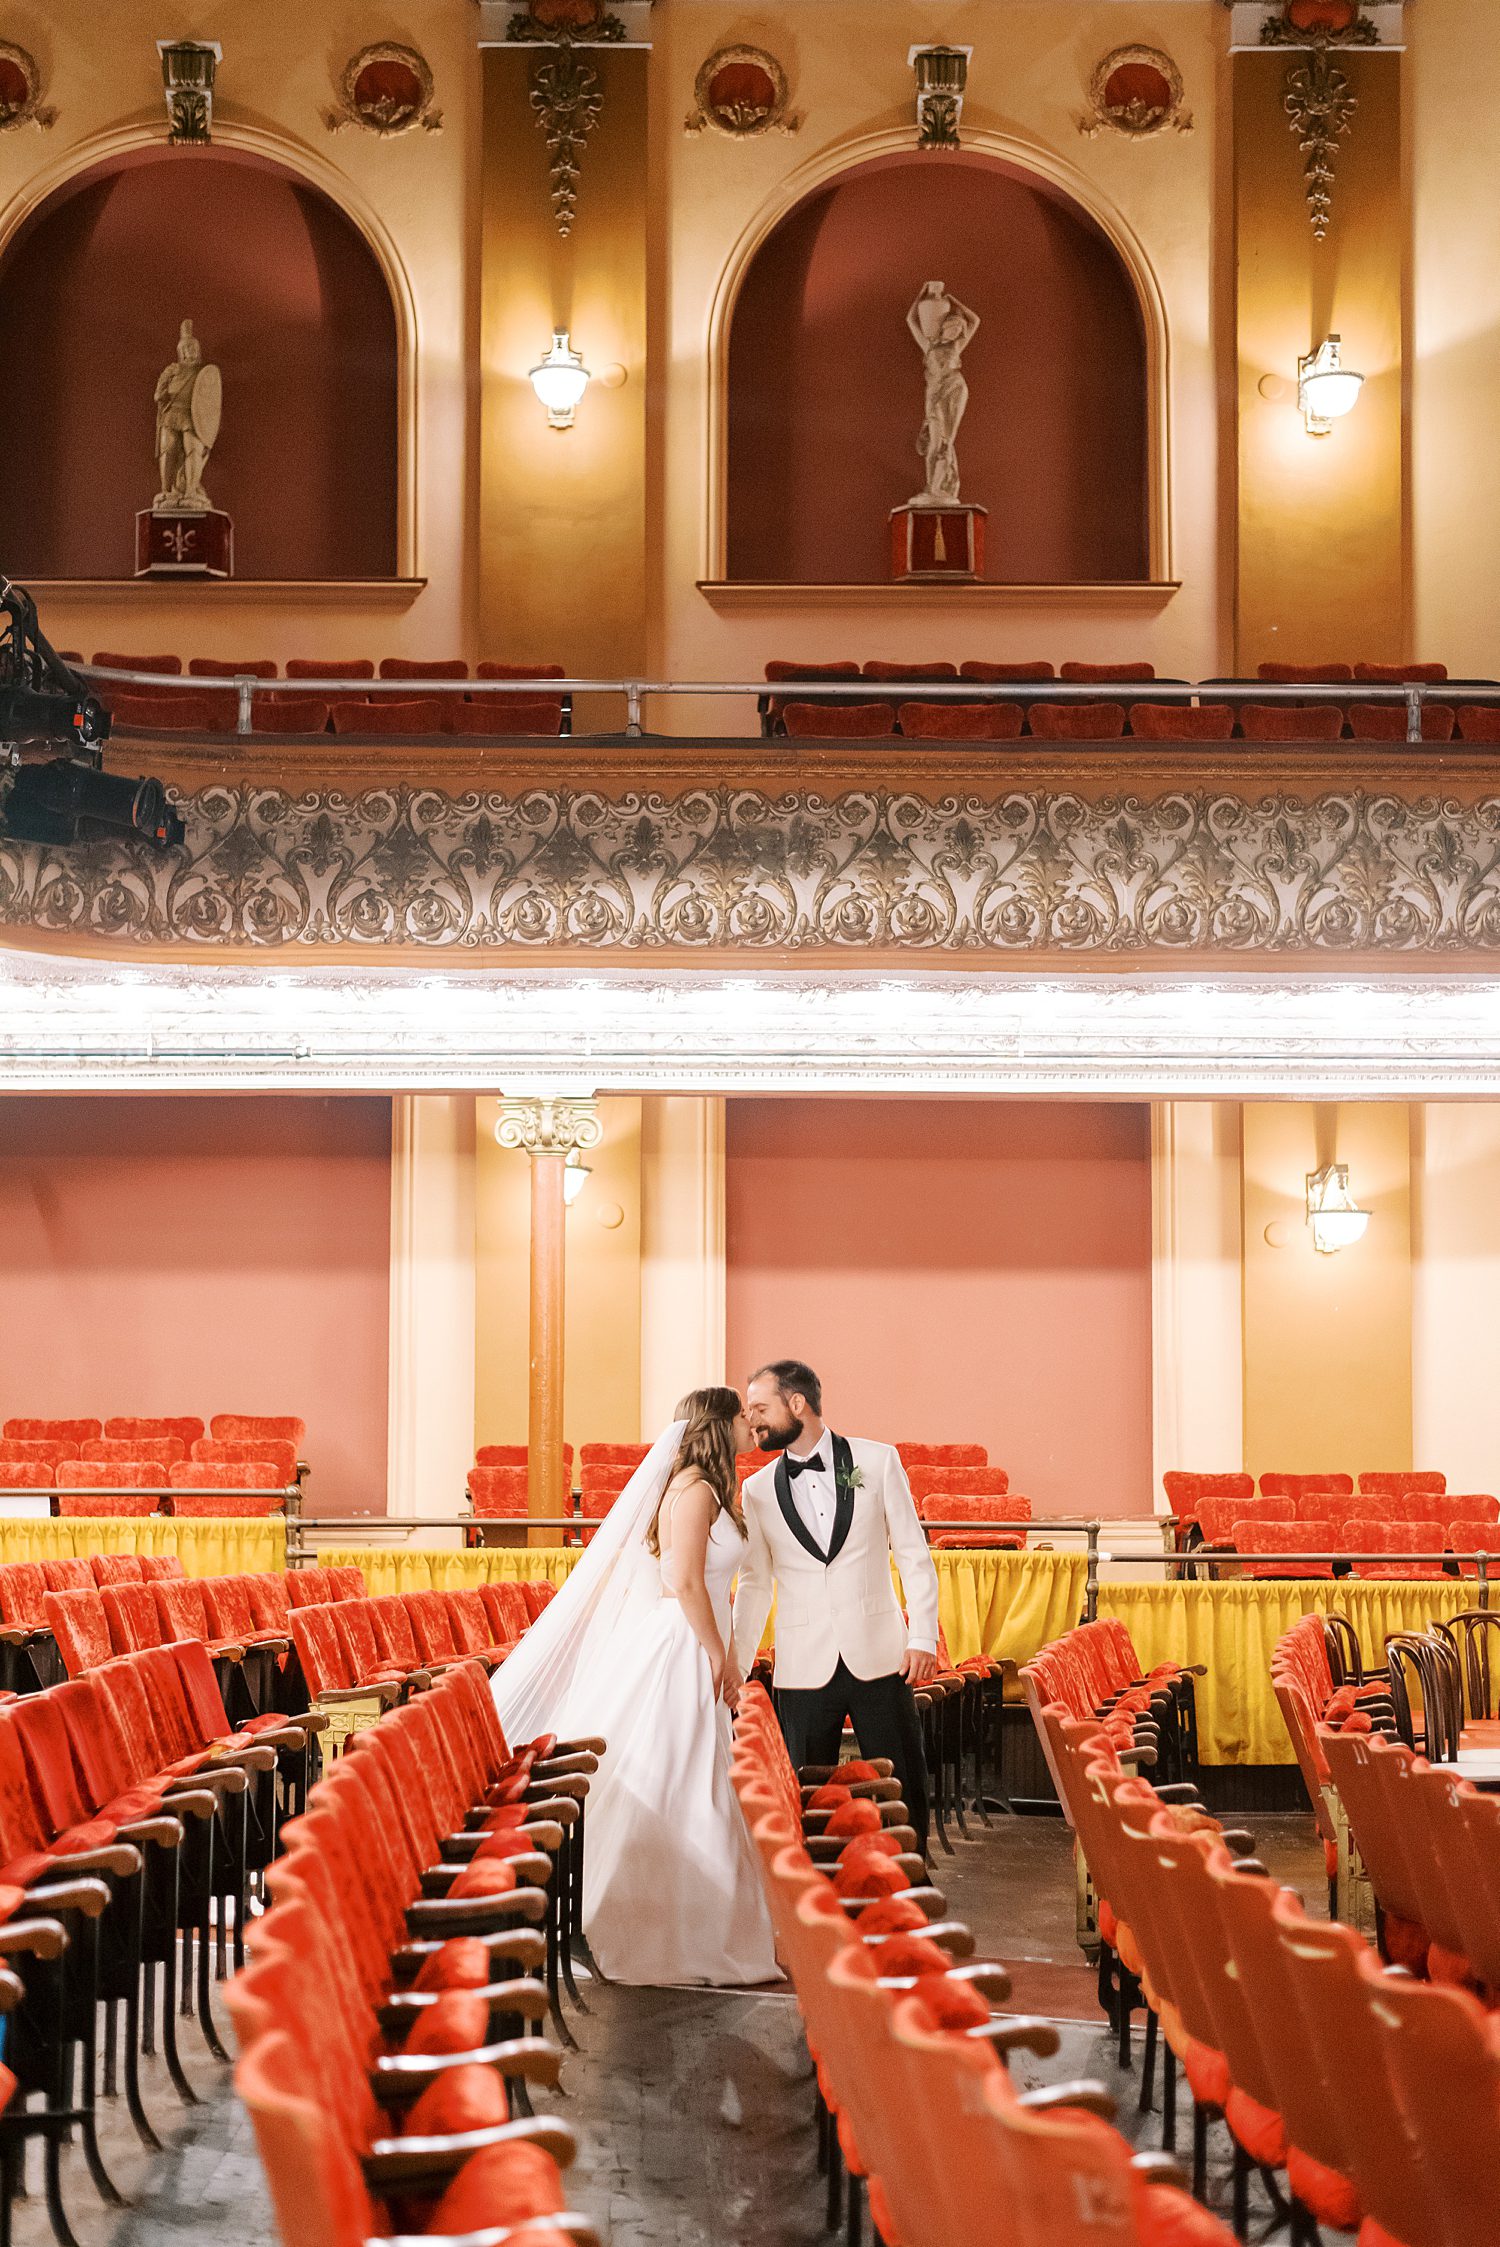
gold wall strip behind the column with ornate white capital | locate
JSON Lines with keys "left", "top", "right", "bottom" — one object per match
{"left": 474, "top": 1099, "right": 640, "bottom": 1454}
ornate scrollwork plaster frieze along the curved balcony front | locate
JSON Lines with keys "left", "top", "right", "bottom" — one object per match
{"left": 0, "top": 782, "right": 1500, "bottom": 966}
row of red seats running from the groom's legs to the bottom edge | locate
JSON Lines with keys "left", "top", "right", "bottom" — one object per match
{"left": 734, "top": 1687, "right": 1228, "bottom": 2247}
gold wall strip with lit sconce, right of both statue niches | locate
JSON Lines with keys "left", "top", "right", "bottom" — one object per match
{"left": 1235, "top": 52, "right": 1408, "bottom": 674}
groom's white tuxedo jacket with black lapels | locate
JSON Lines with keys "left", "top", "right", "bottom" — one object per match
{"left": 734, "top": 1436, "right": 939, "bottom": 1690}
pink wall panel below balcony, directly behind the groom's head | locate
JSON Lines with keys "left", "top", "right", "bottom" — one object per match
{"left": 728, "top": 1099, "right": 1152, "bottom": 1512}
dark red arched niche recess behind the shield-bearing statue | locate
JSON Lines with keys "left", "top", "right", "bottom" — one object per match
{"left": 0, "top": 146, "right": 397, "bottom": 580}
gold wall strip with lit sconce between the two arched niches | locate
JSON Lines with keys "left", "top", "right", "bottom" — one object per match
{"left": 478, "top": 47, "right": 647, "bottom": 678}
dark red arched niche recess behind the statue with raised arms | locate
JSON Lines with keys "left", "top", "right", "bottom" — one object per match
{"left": 725, "top": 153, "right": 1152, "bottom": 584}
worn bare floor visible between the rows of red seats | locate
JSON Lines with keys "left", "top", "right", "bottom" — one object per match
{"left": 16, "top": 1818, "right": 1327, "bottom": 2247}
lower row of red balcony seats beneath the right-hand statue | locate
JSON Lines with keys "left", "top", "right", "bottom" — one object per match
{"left": 779, "top": 699, "right": 1500, "bottom": 744}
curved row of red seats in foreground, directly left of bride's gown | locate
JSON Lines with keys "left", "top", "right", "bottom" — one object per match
{"left": 229, "top": 1663, "right": 595, "bottom": 2247}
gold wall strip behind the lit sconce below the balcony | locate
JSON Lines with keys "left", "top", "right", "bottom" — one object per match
{"left": 1244, "top": 1101, "right": 1410, "bottom": 1474}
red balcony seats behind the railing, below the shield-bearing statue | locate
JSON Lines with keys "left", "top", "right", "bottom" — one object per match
{"left": 65, "top": 649, "right": 573, "bottom": 735}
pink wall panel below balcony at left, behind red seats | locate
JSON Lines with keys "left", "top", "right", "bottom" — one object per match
{"left": 0, "top": 1097, "right": 391, "bottom": 1514}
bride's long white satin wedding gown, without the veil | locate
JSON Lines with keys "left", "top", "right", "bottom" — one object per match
{"left": 579, "top": 1514, "right": 777, "bottom": 1989}
